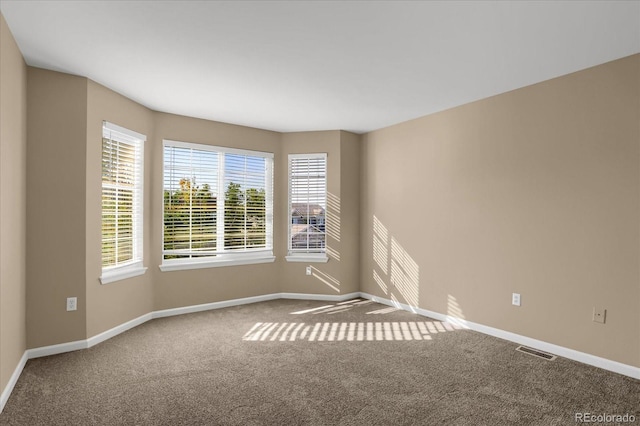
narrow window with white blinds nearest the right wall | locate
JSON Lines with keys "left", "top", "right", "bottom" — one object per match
{"left": 287, "top": 154, "right": 327, "bottom": 260}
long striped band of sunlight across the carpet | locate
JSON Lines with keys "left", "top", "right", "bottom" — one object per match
{"left": 242, "top": 321, "right": 460, "bottom": 342}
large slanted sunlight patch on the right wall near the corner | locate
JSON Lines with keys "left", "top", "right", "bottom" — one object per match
{"left": 373, "top": 215, "right": 420, "bottom": 307}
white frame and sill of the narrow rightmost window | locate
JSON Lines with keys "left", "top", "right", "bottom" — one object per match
{"left": 285, "top": 153, "right": 329, "bottom": 263}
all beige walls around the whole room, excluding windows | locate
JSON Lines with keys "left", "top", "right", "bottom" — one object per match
{"left": 0, "top": 12, "right": 640, "bottom": 382}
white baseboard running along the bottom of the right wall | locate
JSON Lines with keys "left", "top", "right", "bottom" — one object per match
{"left": 360, "top": 292, "right": 640, "bottom": 380}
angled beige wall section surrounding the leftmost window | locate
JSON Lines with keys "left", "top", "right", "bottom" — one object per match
{"left": 85, "top": 80, "right": 154, "bottom": 337}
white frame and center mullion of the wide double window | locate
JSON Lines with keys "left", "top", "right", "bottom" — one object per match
{"left": 159, "top": 139, "right": 275, "bottom": 272}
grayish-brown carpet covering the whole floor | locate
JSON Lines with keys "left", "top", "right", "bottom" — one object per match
{"left": 0, "top": 300, "right": 640, "bottom": 425}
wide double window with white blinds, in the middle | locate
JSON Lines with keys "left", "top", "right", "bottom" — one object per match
{"left": 161, "top": 140, "right": 274, "bottom": 270}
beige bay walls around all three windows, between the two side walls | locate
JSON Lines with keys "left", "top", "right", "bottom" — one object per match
{"left": 21, "top": 68, "right": 350, "bottom": 347}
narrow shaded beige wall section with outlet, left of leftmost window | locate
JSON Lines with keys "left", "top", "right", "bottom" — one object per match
{"left": 27, "top": 67, "right": 87, "bottom": 348}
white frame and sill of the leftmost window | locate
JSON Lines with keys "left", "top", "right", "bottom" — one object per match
{"left": 100, "top": 121, "right": 147, "bottom": 284}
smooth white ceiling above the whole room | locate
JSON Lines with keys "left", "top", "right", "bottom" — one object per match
{"left": 0, "top": 0, "right": 640, "bottom": 133}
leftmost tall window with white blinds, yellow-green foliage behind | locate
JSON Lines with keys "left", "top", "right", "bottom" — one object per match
{"left": 101, "top": 121, "right": 146, "bottom": 284}
